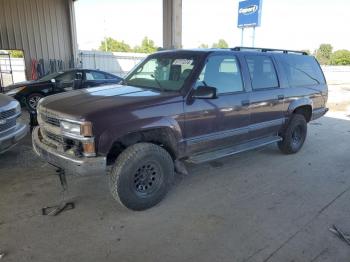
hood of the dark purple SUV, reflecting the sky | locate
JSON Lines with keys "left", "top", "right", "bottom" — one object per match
{"left": 40, "top": 85, "right": 182, "bottom": 120}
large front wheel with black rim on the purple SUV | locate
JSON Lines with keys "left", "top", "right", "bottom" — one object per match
{"left": 110, "top": 143, "right": 174, "bottom": 210}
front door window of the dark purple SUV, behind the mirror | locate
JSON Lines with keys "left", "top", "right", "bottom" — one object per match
{"left": 196, "top": 55, "right": 243, "bottom": 94}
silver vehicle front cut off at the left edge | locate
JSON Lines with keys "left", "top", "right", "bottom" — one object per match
{"left": 0, "top": 94, "right": 28, "bottom": 154}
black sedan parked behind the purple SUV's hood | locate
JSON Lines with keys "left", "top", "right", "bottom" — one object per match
{"left": 6, "top": 69, "right": 122, "bottom": 111}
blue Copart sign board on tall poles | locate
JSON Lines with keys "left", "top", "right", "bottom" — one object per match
{"left": 237, "top": 0, "right": 261, "bottom": 28}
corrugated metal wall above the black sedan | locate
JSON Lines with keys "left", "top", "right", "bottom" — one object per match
{"left": 0, "top": 0, "right": 76, "bottom": 77}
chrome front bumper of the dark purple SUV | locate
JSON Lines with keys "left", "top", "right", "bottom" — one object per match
{"left": 32, "top": 127, "right": 106, "bottom": 175}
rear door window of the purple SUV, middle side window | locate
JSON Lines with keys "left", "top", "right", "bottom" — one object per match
{"left": 246, "top": 55, "right": 278, "bottom": 90}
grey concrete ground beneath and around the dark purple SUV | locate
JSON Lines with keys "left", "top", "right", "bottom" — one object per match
{"left": 0, "top": 85, "right": 350, "bottom": 262}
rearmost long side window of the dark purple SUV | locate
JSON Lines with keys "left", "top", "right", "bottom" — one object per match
{"left": 280, "top": 55, "right": 325, "bottom": 87}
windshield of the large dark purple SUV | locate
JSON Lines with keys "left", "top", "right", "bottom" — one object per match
{"left": 124, "top": 55, "right": 196, "bottom": 91}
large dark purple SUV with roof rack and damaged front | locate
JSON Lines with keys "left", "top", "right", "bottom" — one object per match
{"left": 33, "top": 48, "right": 328, "bottom": 210}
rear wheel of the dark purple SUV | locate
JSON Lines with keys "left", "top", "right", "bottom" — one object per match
{"left": 278, "top": 114, "right": 307, "bottom": 154}
